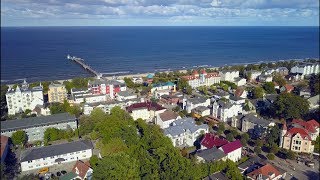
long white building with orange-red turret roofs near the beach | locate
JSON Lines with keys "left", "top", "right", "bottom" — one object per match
{"left": 181, "top": 69, "right": 221, "bottom": 88}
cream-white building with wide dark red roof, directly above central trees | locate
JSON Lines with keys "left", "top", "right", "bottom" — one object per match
{"left": 126, "top": 102, "right": 166, "bottom": 122}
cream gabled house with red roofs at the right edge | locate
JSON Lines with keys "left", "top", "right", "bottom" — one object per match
{"left": 279, "top": 119, "right": 319, "bottom": 153}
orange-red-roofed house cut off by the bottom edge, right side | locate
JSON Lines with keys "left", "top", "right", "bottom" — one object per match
{"left": 247, "top": 163, "right": 286, "bottom": 180}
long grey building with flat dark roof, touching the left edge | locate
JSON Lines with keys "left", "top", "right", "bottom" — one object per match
{"left": 1, "top": 113, "right": 77, "bottom": 142}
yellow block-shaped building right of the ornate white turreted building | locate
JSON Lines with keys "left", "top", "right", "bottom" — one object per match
{"left": 48, "top": 84, "right": 67, "bottom": 103}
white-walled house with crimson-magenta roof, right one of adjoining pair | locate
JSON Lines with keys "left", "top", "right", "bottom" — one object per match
{"left": 219, "top": 139, "right": 242, "bottom": 162}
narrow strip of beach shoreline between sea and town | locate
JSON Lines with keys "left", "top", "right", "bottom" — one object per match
{"left": 1, "top": 58, "right": 319, "bottom": 86}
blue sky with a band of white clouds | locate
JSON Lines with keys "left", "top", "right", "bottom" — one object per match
{"left": 1, "top": 0, "right": 319, "bottom": 26}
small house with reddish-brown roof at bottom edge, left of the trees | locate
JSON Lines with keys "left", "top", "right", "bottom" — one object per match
{"left": 59, "top": 160, "right": 93, "bottom": 180}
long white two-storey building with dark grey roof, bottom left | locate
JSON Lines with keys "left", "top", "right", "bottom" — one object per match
{"left": 20, "top": 140, "right": 93, "bottom": 172}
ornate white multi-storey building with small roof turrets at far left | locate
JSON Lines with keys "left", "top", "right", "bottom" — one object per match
{"left": 6, "top": 81, "right": 44, "bottom": 115}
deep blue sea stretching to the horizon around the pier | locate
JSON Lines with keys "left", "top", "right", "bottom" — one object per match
{"left": 1, "top": 26, "right": 319, "bottom": 83}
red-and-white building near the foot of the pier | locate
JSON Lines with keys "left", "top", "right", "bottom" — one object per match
{"left": 88, "top": 79, "right": 127, "bottom": 99}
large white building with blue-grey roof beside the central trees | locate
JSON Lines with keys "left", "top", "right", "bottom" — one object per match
{"left": 164, "top": 118, "right": 209, "bottom": 147}
